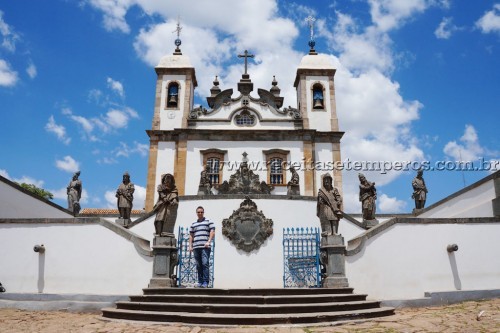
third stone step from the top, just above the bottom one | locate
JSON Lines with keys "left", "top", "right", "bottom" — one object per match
{"left": 116, "top": 301, "right": 380, "bottom": 315}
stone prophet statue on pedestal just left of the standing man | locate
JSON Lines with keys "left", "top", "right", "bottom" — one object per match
{"left": 153, "top": 173, "right": 179, "bottom": 236}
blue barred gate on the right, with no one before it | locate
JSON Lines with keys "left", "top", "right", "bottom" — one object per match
{"left": 283, "top": 228, "right": 321, "bottom": 288}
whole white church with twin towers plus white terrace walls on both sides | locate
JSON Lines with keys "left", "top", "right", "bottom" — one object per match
{"left": 0, "top": 33, "right": 500, "bottom": 310}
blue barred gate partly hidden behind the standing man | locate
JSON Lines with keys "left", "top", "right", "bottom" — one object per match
{"left": 176, "top": 227, "right": 215, "bottom": 288}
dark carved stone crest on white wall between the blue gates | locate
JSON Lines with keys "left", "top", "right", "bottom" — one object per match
{"left": 222, "top": 196, "right": 273, "bottom": 252}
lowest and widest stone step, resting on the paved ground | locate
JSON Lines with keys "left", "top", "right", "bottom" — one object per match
{"left": 102, "top": 307, "right": 394, "bottom": 326}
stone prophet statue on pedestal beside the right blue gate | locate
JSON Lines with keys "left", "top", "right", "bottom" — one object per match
{"left": 316, "top": 174, "right": 342, "bottom": 236}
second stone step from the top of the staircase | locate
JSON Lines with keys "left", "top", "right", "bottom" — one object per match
{"left": 130, "top": 294, "right": 367, "bottom": 304}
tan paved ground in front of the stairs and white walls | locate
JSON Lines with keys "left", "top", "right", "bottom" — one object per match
{"left": 0, "top": 298, "right": 500, "bottom": 333}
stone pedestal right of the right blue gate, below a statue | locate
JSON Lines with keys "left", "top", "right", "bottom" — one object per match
{"left": 320, "top": 235, "right": 349, "bottom": 288}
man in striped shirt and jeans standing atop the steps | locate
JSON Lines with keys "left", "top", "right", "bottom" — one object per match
{"left": 189, "top": 206, "right": 215, "bottom": 288}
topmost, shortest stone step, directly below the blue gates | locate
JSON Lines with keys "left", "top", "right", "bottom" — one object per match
{"left": 143, "top": 288, "right": 354, "bottom": 296}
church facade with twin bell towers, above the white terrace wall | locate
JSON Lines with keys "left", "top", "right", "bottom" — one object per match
{"left": 145, "top": 42, "right": 343, "bottom": 211}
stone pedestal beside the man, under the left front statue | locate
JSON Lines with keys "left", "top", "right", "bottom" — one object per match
{"left": 148, "top": 233, "right": 179, "bottom": 288}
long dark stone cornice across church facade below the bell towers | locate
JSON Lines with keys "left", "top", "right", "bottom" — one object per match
{"left": 146, "top": 128, "right": 344, "bottom": 143}
